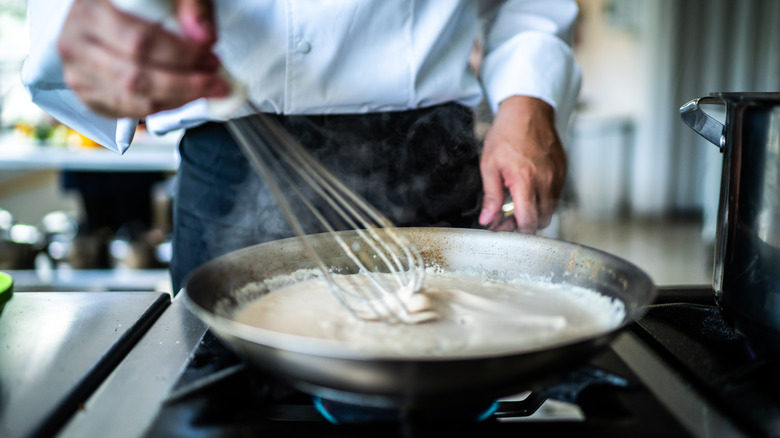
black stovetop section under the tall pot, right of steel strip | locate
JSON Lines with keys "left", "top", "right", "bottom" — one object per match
{"left": 633, "top": 289, "right": 780, "bottom": 437}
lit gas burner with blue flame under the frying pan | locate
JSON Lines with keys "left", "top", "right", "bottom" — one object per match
{"left": 313, "top": 397, "right": 498, "bottom": 424}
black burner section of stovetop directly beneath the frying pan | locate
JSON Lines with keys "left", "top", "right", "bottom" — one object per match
{"left": 144, "top": 333, "right": 687, "bottom": 438}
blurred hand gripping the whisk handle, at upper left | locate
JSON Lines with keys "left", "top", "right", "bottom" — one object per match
{"left": 57, "top": 0, "right": 230, "bottom": 118}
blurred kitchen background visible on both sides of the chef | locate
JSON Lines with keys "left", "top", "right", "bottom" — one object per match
{"left": 0, "top": 0, "right": 780, "bottom": 290}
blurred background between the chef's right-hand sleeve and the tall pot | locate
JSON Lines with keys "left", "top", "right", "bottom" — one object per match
{"left": 561, "top": 0, "right": 780, "bottom": 284}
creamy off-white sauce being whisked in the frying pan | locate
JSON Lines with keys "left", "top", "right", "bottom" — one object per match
{"left": 234, "top": 272, "right": 625, "bottom": 357}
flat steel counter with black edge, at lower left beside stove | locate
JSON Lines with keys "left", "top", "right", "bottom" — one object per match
{"left": 0, "top": 292, "right": 171, "bottom": 437}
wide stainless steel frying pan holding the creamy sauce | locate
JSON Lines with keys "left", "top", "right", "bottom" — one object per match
{"left": 183, "top": 228, "right": 656, "bottom": 409}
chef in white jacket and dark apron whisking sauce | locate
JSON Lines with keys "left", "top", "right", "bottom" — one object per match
{"left": 22, "top": 0, "right": 581, "bottom": 290}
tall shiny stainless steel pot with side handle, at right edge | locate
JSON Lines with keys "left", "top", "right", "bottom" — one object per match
{"left": 680, "top": 93, "right": 780, "bottom": 349}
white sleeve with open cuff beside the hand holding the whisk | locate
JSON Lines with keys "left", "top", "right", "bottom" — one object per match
{"left": 21, "top": 0, "right": 135, "bottom": 153}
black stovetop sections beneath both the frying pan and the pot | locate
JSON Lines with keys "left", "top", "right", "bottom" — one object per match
{"left": 142, "top": 289, "right": 780, "bottom": 438}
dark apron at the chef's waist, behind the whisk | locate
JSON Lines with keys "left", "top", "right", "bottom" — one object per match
{"left": 171, "top": 104, "right": 482, "bottom": 292}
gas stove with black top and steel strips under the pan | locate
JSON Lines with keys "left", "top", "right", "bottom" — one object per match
{"left": 3, "top": 287, "right": 780, "bottom": 438}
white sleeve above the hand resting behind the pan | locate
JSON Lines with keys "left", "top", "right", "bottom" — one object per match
{"left": 480, "top": 0, "right": 582, "bottom": 128}
